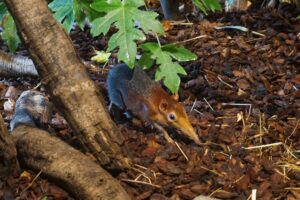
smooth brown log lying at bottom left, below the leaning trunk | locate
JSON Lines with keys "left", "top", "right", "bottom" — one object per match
{"left": 12, "top": 125, "right": 130, "bottom": 200}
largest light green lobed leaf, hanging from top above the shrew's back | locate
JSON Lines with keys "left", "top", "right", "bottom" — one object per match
{"left": 91, "top": 0, "right": 164, "bottom": 67}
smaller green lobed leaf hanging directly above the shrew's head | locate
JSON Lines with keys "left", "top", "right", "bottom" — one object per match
{"left": 140, "top": 42, "right": 196, "bottom": 93}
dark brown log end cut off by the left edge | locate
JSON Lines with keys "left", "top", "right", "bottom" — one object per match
{"left": 0, "top": 115, "right": 20, "bottom": 177}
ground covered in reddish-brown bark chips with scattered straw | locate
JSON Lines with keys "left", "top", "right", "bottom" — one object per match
{"left": 0, "top": 1, "right": 300, "bottom": 200}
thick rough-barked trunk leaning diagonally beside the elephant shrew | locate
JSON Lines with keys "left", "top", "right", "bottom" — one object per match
{"left": 5, "top": 0, "right": 130, "bottom": 169}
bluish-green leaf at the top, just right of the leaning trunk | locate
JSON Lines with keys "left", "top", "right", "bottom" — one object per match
{"left": 48, "top": 0, "right": 75, "bottom": 33}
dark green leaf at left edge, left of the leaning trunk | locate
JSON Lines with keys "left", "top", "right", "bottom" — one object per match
{"left": 2, "top": 14, "right": 20, "bottom": 52}
